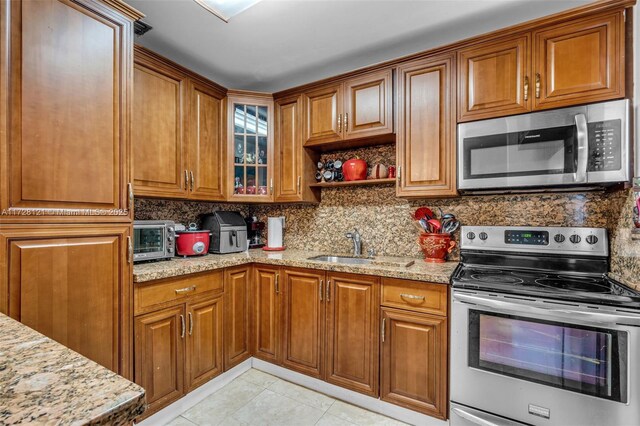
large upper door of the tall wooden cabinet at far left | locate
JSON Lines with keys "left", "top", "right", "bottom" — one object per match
{"left": 0, "top": 0, "right": 132, "bottom": 221}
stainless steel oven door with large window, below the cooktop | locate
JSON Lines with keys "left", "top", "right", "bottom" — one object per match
{"left": 451, "top": 290, "right": 640, "bottom": 426}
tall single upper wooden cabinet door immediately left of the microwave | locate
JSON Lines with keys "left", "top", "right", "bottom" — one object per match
{"left": 397, "top": 55, "right": 456, "bottom": 197}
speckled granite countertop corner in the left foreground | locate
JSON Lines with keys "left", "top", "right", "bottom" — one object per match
{"left": 0, "top": 314, "right": 145, "bottom": 425}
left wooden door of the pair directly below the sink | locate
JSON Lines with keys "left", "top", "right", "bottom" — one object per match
{"left": 282, "top": 269, "right": 325, "bottom": 379}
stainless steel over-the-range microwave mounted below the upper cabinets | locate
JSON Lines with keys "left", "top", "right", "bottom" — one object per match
{"left": 458, "top": 99, "right": 631, "bottom": 192}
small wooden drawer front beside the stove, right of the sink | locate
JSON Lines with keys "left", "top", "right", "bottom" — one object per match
{"left": 382, "top": 278, "right": 447, "bottom": 315}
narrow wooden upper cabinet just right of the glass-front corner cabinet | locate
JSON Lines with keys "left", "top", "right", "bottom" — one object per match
{"left": 275, "top": 96, "right": 320, "bottom": 202}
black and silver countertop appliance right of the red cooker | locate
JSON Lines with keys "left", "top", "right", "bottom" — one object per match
{"left": 202, "top": 211, "right": 248, "bottom": 254}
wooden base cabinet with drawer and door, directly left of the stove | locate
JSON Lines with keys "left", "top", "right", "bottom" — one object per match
{"left": 380, "top": 278, "right": 449, "bottom": 420}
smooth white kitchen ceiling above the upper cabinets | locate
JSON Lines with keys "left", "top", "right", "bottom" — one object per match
{"left": 126, "top": 0, "right": 589, "bottom": 92}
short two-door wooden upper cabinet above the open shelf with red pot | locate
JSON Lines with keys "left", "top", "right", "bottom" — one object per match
{"left": 304, "top": 68, "right": 393, "bottom": 148}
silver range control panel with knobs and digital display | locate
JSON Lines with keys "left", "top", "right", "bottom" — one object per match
{"left": 460, "top": 226, "right": 609, "bottom": 256}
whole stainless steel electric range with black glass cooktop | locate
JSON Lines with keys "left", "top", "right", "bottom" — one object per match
{"left": 450, "top": 226, "right": 640, "bottom": 426}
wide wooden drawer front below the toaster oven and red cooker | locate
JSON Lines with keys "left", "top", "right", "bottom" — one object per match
{"left": 134, "top": 269, "right": 223, "bottom": 314}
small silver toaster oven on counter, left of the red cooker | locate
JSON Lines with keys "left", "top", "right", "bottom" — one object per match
{"left": 133, "top": 220, "right": 176, "bottom": 262}
